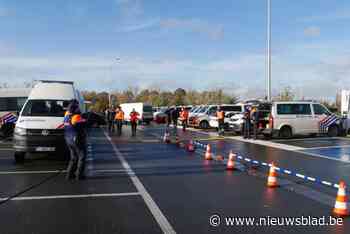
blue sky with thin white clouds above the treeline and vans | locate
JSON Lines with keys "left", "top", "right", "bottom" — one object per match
{"left": 0, "top": 0, "right": 350, "bottom": 98}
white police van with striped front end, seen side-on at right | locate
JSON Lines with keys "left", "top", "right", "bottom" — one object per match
{"left": 263, "top": 101, "right": 342, "bottom": 138}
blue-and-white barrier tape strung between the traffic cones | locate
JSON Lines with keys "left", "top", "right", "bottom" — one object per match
{"left": 194, "top": 141, "right": 339, "bottom": 188}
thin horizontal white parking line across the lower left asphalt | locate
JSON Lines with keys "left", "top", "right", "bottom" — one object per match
{"left": 0, "top": 193, "right": 140, "bottom": 201}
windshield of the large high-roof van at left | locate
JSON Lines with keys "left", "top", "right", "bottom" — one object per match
{"left": 22, "top": 100, "right": 69, "bottom": 117}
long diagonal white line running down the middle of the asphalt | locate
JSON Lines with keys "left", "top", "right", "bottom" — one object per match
{"left": 103, "top": 130, "right": 176, "bottom": 233}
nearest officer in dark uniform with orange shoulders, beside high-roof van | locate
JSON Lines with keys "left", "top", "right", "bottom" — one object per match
{"left": 64, "top": 100, "right": 86, "bottom": 180}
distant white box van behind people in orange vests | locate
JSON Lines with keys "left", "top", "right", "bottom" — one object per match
{"left": 120, "top": 102, "right": 153, "bottom": 124}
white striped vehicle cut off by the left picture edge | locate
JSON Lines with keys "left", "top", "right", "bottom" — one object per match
{"left": 0, "top": 88, "right": 30, "bottom": 137}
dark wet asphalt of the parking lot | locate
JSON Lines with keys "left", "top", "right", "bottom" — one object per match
{"left": 0, "top": 127, "right": 349, "bottom": 234}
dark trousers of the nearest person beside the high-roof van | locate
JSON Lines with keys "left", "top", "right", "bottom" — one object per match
{"left": 66, "top": 140, "right": 86, "bottom": 179}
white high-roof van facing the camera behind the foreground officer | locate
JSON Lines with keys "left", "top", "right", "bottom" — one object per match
{"left": 14, "top": 81, "right": 85, "bottom": 162}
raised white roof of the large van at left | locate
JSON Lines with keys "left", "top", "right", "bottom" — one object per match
{"left": 29, "top": 83, "right": 77, "bottom": 100}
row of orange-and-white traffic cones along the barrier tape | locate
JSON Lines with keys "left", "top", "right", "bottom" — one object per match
{"left": 163, "top": 131, "right": 350, "bottom": 217}
